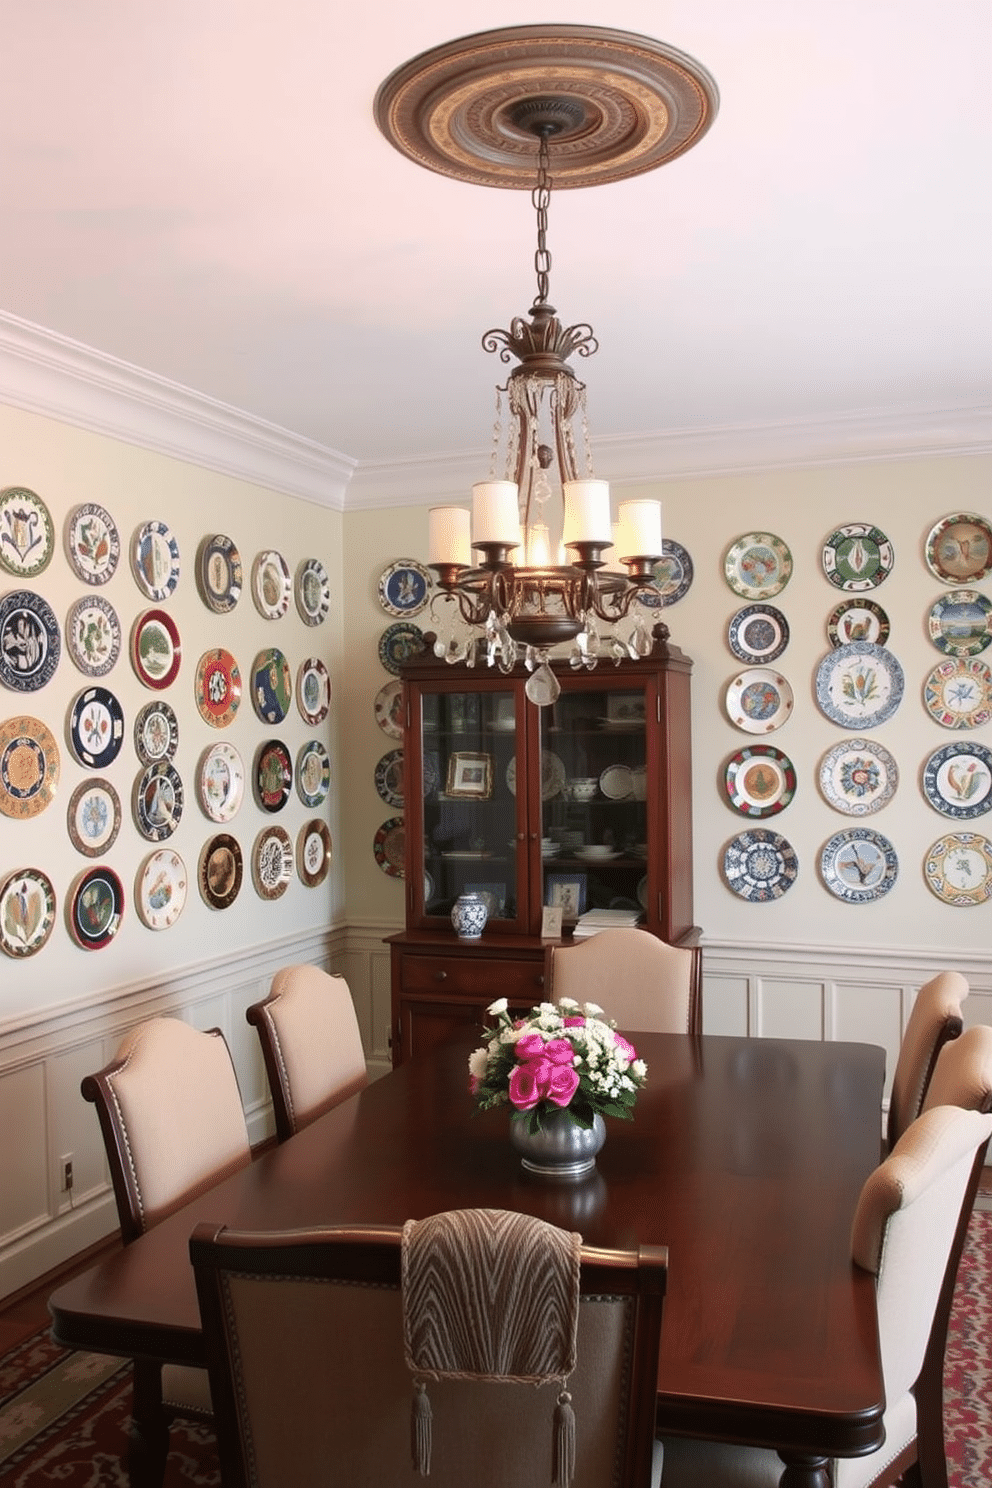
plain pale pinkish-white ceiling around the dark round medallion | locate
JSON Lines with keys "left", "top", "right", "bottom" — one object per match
{"left": 0, "top": 0, "right": 992, "bottom": 491}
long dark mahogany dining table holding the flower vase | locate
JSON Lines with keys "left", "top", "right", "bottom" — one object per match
{"left": 49, "top": 1034, "right": 885, "bottom": 1488}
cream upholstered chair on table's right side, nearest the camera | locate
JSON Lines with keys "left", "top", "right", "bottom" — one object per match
{"left": 662, "top": 1106, "right": 992, "bottom": 1488}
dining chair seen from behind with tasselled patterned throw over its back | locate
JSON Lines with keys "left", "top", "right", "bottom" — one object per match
{"left": 190, "top": 1210, "right": 666, "bottom": 1488}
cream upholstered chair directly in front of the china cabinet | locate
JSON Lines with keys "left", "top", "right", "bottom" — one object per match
{"left": 544, "top": 929, "right": 702, "bottom": 1033}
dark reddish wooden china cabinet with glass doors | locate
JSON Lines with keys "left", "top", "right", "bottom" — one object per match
{"left": 388, "top": 626, "right": 699, "bottom": 1064}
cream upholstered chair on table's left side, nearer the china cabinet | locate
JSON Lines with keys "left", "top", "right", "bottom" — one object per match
{"left": 245, "top": 966, "right": 369, "bottom": 1141}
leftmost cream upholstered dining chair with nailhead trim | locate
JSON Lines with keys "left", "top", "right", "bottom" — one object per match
{"left": 82, "top": 1018, "right": 251, "bottom": 1488}
